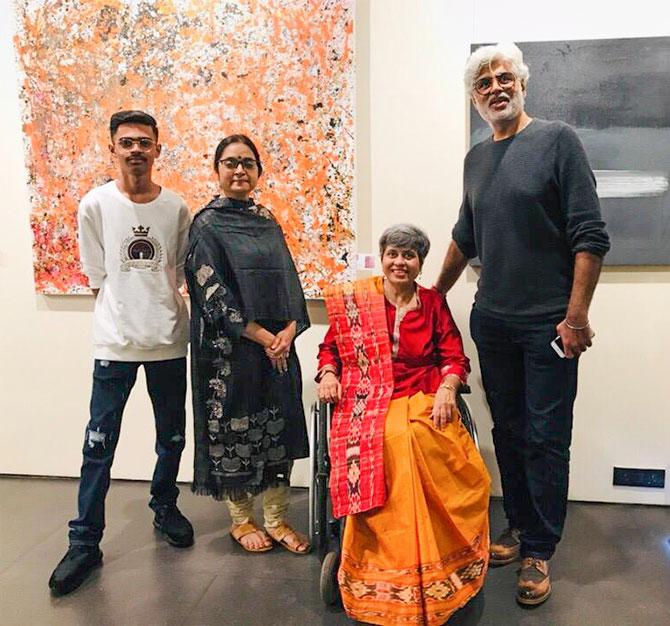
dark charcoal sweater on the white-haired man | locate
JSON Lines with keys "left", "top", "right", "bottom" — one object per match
{"left": 453, "top": 119, "right": 610, "bottom": 321}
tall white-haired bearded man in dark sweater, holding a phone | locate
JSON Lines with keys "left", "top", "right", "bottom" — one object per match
{"left": 436, "top": 44, "right": 609, "bottom": 604}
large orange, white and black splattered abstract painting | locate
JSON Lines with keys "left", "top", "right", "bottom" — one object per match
{"left": 15, "top": 0, "right": 355, "bottom": 297}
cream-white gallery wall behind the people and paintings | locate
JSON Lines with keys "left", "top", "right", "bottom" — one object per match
{"left": 0, "top": 0, "right": 670, "bottom": 509}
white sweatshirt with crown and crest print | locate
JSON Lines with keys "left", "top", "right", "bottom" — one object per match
{"left": 78, "top": 181, "right": 191, "bottom": 361}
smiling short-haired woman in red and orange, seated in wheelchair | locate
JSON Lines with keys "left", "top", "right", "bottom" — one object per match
{"left": 317, "top": 224, "right": 490, "bottom": 624}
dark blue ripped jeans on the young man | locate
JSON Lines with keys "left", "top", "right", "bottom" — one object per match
{"left": 69, "top": 358, "right": 186, "bottom": 546}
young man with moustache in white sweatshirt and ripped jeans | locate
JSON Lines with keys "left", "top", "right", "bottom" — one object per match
{"left": 49, "top": 111, "right": 193, "bottom": 595}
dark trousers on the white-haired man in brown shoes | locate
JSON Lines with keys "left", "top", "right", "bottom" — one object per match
{"left": 470, "top": 308, "right": 577, "bottom": 559}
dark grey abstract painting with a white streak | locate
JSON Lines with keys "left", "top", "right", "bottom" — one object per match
{"left": 470, "top": 37, "right": 670, "bottom": 265}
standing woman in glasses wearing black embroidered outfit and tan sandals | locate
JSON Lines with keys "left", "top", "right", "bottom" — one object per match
{"left": 185, "top": 135, "right": 309, "bottom": 554}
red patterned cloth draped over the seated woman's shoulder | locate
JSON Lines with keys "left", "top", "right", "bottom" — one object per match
{"left": 325, "top": 277, "right": 393, "bottom": 517}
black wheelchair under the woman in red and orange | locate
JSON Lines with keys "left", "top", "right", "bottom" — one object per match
{"left": 309, "top": 385, "right": 479, "bottom": 606}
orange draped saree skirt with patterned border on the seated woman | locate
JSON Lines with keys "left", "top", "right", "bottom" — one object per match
{"left": 339, "top": 392, "right": 489, "bottom": 625}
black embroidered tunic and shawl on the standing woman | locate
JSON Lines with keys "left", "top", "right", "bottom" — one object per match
{"left": 185, "top": 198, "right": 309, "bottom": 499}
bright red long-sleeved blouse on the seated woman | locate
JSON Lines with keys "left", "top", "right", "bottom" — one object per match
{"left": 319, "top": 285, "right": 470, "bottom": 398}
